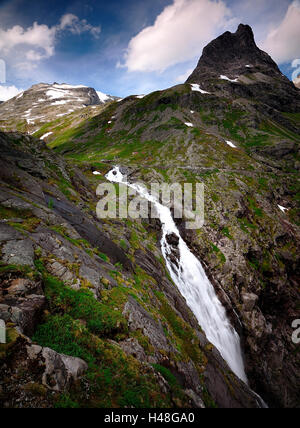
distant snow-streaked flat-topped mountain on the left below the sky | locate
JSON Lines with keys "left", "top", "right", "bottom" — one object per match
{"left": 0, "top": 83, "right": 117, "bottom": 134}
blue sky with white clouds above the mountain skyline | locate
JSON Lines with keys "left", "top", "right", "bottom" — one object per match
{"left": 0, "top": 0, "right": 300, "bottom": 97}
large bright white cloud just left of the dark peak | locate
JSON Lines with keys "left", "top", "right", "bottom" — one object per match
{"left": 125, "top": 0, "right": 230, "bottom": 71}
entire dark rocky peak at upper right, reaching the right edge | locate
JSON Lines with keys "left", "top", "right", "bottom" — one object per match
{"left": 186, "top": 24, "right": 300, "bottom": 114}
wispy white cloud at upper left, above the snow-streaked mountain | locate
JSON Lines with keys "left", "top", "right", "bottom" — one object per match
{"left": 0, "top": 14, "right": 101, "bottom": 72}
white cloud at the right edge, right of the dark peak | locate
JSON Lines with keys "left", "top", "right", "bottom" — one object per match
{"left": 261, "top": 0, "right": 300, "bottom": 64}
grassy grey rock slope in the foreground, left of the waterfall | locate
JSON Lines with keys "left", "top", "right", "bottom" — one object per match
{"left": 0, "top": 133, "right": 259, "bottom": 408}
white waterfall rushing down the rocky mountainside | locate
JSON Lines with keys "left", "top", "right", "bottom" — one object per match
{"left": 106, "top": 167, "right": 248, "bottom": 383}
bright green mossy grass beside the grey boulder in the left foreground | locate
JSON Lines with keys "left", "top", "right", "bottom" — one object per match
{"left": 32, "top": 273, "right": 184, "bottom": 408}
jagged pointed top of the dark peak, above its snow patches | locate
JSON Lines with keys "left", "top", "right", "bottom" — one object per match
{"left": 187, "top": 24, "right": 281, "bottom": 83}
